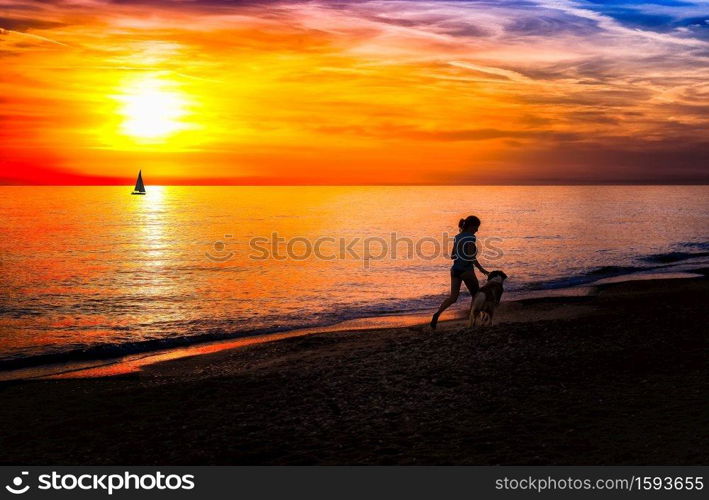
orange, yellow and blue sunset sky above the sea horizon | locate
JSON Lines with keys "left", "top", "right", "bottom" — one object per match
{"left": 0, "top": 0, "right": 709, "bottom": 184}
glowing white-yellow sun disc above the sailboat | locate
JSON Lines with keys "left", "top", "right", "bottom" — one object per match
{"left": 116, "top": 76, "right": 188, "bottom": 142}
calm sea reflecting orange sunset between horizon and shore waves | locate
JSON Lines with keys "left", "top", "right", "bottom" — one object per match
{"left": 0, "top": 186, "right": 709, "bottom": 367}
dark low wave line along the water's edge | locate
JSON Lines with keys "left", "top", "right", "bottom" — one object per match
{"left": 0, "top": 243, "right": 709, "bottom": 370}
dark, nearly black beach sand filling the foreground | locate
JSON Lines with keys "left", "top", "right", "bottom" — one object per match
{"left": 0, "top": 279, "right": 709, "bottom": 465}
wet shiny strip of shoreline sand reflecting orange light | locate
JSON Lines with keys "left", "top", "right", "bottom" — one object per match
{"left": 0, "top": 266, "right": 704, "bottom": 383}
